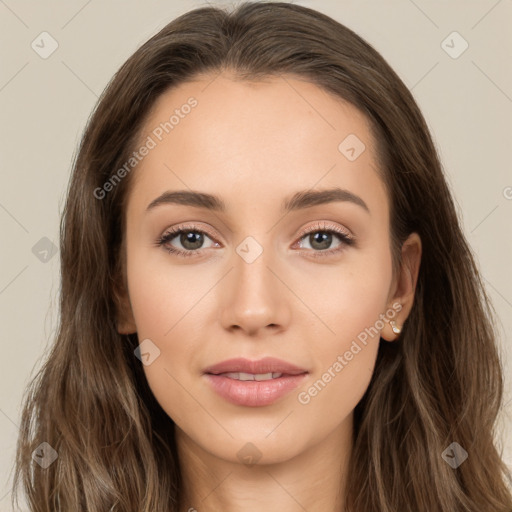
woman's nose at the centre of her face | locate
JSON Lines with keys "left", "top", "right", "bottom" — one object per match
{"left": 220, "top": 246, "right": 291, "bottom": 336}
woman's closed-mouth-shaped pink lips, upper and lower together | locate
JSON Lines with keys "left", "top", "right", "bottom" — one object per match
{"left": 204, "top": 357, "right": 309, "bottom": 407}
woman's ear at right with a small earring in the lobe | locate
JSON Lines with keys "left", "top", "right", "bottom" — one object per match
{"left": 380, "top": 233, "right": 421, "bottom": 341}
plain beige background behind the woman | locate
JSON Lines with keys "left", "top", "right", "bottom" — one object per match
{"left": 0, "top": 0, "right": 512, "bottom": 512}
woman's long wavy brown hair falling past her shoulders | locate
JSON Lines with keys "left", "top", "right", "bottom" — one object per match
{"left": 13, "top": 2, "right": 512, "bottom": 512}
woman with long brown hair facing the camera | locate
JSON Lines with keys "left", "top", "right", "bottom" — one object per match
{"left": 15, "top": 3, "right": 512, "bottom": 512}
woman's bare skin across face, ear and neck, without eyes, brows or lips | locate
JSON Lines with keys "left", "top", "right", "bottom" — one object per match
{"left": 118, "top": 72, "right": 421, "bottom": 512}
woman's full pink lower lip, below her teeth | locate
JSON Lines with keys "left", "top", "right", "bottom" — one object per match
{"left": 204, "top": 373, "right": 307, "bottom": 407}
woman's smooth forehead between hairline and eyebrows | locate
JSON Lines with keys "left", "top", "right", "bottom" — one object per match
{"left": 126, "top": 74, "right": 387, "bottom": 216}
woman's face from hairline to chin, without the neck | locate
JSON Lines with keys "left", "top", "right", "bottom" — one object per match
{"left": 119, "top": 74, "right": 418, "bottom": 463}
